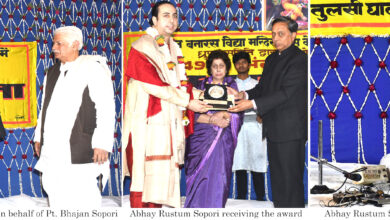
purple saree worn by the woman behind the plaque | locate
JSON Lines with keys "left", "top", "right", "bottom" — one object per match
{"left": 184, "top": 77, "right": 243, "bottom": 208}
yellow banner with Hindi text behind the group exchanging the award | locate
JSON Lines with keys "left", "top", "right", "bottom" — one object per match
{"left": 124, "top": 31, "right": 308, "bottom": 76}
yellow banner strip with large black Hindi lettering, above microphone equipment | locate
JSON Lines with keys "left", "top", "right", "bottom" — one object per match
{"left": 310, "top": 0, "right": 390, "bottom": 36}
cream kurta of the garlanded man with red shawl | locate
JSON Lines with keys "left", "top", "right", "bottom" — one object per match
{"left": 122, "top": 27, "right": 199, "bottom": 207}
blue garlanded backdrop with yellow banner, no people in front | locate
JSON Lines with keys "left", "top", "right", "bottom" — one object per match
{"left": 310, "top": 0, "right": 390, "bottom": 167}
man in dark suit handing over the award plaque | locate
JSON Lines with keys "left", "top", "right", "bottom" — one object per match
{"left": 229, "top": 17, "right": 307, "bottom": 207}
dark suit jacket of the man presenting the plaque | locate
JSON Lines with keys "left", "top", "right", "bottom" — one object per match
{"left": 247, "top": 45, "right": 308, "bottom": 142}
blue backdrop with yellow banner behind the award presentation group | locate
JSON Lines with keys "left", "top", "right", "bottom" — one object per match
{"left": 123, "top": 0, "right": 308, "bottom": 204}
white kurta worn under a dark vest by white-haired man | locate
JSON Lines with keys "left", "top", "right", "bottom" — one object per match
{"left": 34, "top": 55, "right": 115, "bottom": 207}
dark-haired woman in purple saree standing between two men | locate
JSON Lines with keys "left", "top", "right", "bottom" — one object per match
{"left": 184, "top": 50, "right": 243, "bottom": 208}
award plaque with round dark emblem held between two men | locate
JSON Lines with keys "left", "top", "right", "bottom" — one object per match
{"left": 203, "top": 84, "right": 234, "bottom": 110}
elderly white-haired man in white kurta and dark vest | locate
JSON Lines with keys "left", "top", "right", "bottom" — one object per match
{"left": 34, "top": 26, "right": 115, "bottom": 207}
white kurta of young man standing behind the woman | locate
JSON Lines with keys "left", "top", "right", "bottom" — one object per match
{"left": 232, "top": 77, "right": 267, "bottom": 173}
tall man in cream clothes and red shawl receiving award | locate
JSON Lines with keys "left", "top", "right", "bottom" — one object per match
{"left": 122, "top": 1, "right": 208, "bottom": 208}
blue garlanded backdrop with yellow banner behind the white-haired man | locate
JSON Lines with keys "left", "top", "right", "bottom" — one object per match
{"left": 0, "top": 0, "right": 122, "bottom": 197}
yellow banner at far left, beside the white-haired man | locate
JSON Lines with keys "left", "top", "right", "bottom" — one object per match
{"left": 0, "top": 42, "right": 37, "bottom": 129}
